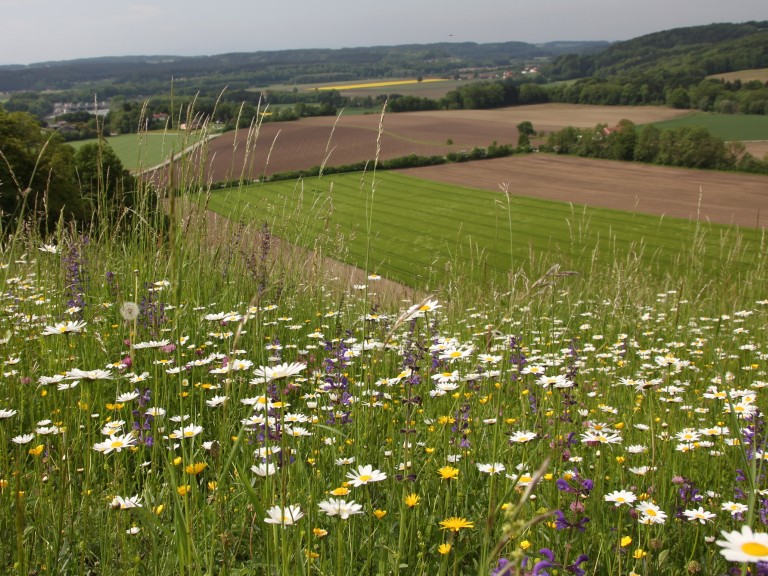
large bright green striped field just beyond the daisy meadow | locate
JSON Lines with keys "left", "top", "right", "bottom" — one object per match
{"left": 204, "top": 172, "right": 760, "bottom": 288}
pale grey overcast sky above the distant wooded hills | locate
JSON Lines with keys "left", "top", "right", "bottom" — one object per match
{"left": 0, "top": 0, "right": 768, "bottom": 64}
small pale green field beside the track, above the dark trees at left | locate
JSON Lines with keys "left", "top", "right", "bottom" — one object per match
{"left": 71, "top": 130, "right": 208, "bottom": 171}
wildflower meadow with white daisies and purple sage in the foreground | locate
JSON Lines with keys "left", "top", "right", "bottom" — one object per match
{"left": 0, "top": 115, "right": 768, "bottom": 576}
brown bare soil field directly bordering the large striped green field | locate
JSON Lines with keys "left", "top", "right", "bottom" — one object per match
{"left": 401, "top": 154, "right": 768, "bottom": 227}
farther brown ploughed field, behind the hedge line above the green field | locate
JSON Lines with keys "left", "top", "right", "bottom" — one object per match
{"left": 194, "top": 104, "right": 687, "bottom": 182}
